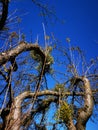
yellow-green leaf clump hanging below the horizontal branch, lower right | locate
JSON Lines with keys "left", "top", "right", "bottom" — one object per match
{"left": 56, "top": 101, "right": 73, "bottom": 122}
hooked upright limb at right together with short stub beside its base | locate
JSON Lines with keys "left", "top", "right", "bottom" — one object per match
{"left": 65, "top": 77, "right": 94, "bottom": 130}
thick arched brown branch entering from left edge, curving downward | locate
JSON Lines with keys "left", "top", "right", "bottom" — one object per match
{"left": 0, "top": 42, "right": 45, "bottom": 66}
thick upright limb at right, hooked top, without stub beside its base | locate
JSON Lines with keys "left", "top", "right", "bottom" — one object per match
{"left": 76, "top": 77, "right": 94, "bottom": 130}
